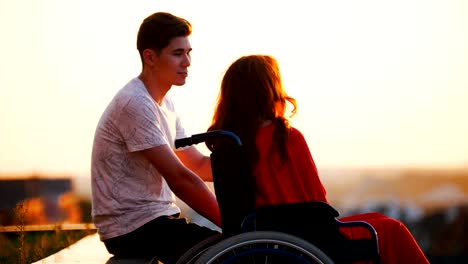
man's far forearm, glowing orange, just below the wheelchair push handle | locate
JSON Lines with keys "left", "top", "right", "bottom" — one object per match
{"left": 175, "top": 146, "right": 213, "bottom": 182}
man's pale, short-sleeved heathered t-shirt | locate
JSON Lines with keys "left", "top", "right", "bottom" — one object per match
{"left": 91, "top": 78, "right": 186, "bottom": 240}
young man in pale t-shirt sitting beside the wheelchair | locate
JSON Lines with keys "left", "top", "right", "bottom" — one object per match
{"left": 91, "top": 12, "right": 220, "bottom": 264}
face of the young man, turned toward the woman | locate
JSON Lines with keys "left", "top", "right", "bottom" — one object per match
{"left": 154, "top": 37, "right": 192, "bottom": 86}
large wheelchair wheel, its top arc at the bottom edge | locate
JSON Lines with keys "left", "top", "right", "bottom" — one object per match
{"left": 194, "top": 231, "right": 333, "bottom": 264}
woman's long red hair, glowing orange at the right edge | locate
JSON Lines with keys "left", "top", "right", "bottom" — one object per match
{"left": 208, "top": 55, "right": 296, "bottom": 168}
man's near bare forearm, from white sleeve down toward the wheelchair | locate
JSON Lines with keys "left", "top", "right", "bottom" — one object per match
{"left": 142, "top": 145, "right": 221, "bottom": 226}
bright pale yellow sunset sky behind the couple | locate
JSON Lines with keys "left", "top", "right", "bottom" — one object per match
{"left": 0, "top": 0, "right": 468, "bottom": 176}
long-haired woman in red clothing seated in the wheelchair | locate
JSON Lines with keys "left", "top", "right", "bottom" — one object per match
{"left": 209, "top": 55, "right": 428, "bottom": 263}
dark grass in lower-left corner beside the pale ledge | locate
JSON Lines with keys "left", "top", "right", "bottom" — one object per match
{"left": 0, "top": 203, "right": 96, "bottom": 264}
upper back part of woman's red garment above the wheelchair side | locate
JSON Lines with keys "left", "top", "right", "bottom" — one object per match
{"left": 253, "top": 124, "right": 327, "bottom": 208}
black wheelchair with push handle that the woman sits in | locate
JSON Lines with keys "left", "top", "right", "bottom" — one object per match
{"left": 175, "top": 130, "right": 379, "bottom": 264}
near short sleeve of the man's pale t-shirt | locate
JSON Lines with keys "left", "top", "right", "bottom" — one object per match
{"left": 116, "top": 93, "right": 168, "bottom": 152}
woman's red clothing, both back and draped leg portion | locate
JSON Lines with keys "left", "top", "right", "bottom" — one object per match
{"left": 254, "top": 124, "right": 429, "bottom": 264}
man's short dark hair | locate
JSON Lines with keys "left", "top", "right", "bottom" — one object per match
{"left": 137, "top": 12, "right": 192, "bottom": 60}
